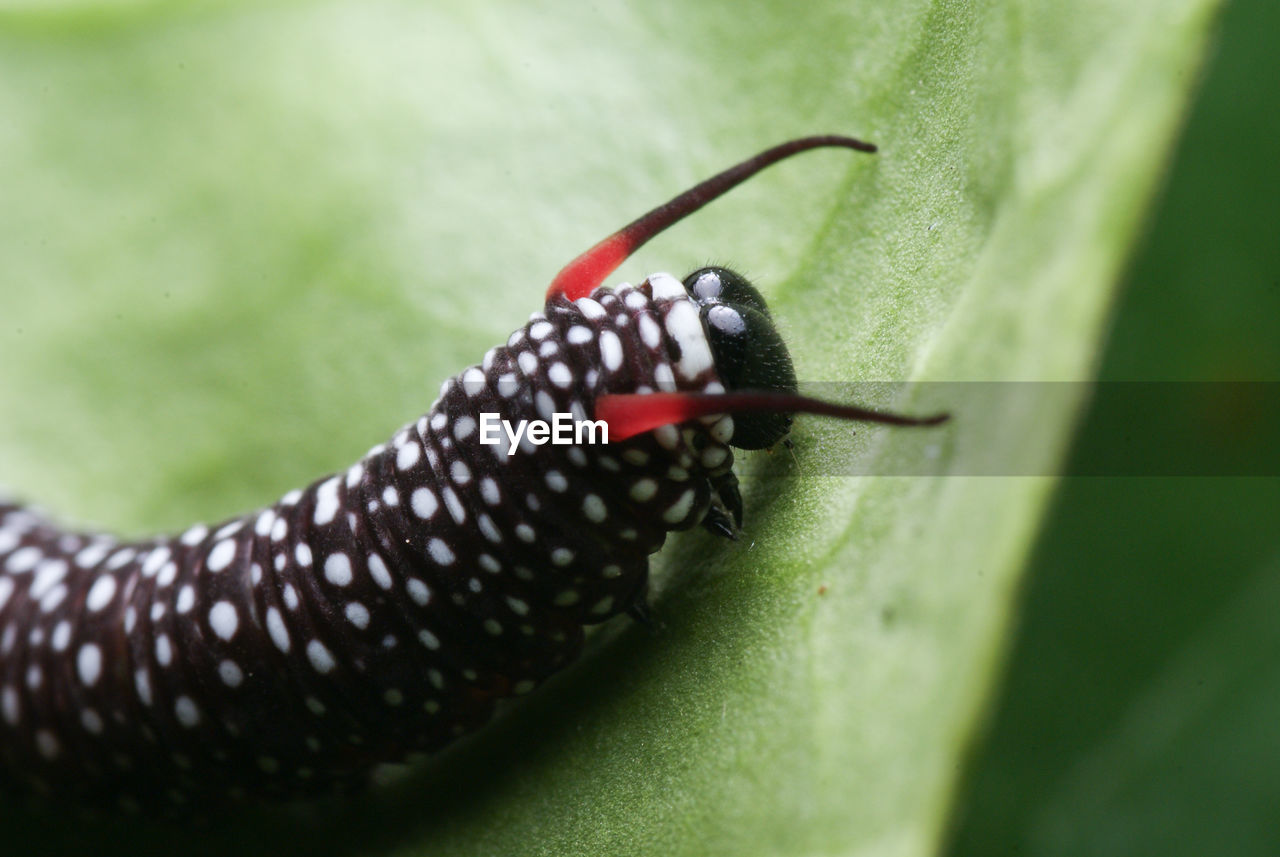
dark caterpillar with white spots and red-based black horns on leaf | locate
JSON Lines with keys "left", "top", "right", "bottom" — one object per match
{"left": 0, "top": 136, "right": 946, "bottom": 811}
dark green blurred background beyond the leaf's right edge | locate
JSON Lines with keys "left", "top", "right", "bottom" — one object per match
{"left": 950, "top": 0, "right": 1280, "bottom": 857}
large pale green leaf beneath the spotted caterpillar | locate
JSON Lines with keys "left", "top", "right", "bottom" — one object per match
{"left": 0, "top": 0, "right": 1215, "bottom": 854}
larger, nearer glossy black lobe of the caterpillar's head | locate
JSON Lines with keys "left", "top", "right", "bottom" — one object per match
{"left": 701, "top": 303, "right": 796, "bottom": 449}
